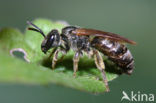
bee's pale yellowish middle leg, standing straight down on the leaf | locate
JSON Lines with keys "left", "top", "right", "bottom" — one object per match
{"left": 73, "top": 52, "right": 80, "bottom": 77}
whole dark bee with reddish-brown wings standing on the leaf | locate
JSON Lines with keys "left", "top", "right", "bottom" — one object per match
{"left": 27, "top": 21, "right": 136, "bottom": 91}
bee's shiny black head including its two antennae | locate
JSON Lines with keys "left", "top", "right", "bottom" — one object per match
{"left": 27, "top": 21, "right": 60, "bottom": 54}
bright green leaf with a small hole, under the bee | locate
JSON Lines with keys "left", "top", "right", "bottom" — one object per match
{"left": 0, "top": 19, "right": 118, "bottom": 93}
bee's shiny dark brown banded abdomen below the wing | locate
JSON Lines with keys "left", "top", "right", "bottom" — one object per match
{"left": 91, "top": 37, "right": 134, "bottom": 74}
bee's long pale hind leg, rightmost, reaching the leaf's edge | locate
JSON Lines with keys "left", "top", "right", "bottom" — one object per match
{"left": 94, "top": 50, "right": 109, "bottom": 92}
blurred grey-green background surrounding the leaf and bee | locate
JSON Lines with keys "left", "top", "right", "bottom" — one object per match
{"left": 0, "top": 0, "right": 156, "bottom": 103}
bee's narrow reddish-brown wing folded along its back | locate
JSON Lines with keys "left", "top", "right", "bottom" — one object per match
{"left": 72, "top": 28, "right": 136, "bottom": 45}
